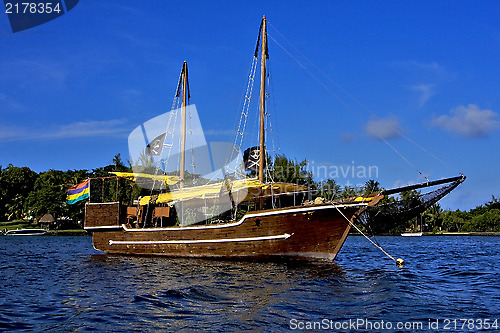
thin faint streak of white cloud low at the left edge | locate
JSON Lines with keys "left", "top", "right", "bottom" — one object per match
{"left": 0, "top": 119, "right": 129, "bottom": 141}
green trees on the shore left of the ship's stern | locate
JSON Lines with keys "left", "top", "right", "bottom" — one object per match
{"left": 0, "top": 154, "right": 135, "bottom": 221}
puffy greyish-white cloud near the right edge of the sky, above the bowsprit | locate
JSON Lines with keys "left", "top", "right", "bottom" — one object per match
{"left": 432, "top": 104, "right": 500, "bottom": 138}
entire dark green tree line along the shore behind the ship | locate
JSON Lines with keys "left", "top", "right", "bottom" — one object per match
{"left": 0, "top": 154, "right": 500, "bottom": 234}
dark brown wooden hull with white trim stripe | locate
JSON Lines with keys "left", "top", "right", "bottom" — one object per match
{"left": 85, "top": 203, "right": 363, "bottom": 259}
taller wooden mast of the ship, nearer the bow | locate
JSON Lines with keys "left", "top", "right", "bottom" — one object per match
{"left": 259, "top": 16, "right": 267, "bottom": 182}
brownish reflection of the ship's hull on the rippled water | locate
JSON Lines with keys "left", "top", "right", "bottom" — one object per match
{"left": 76, "top": 255, "right": 345, "bottom": 329}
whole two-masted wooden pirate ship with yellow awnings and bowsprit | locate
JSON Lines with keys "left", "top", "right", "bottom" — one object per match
{"left": 85, "top": 17, "right": 465, "bottom": 259}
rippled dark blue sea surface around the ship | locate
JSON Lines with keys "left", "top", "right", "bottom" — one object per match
{"left": 0, "top": 236, "right": 500, "bottom": 332}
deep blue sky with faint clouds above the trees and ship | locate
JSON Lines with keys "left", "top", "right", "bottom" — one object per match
{"left": 0, "top": 0, "right": 500, "bottom": 209}
